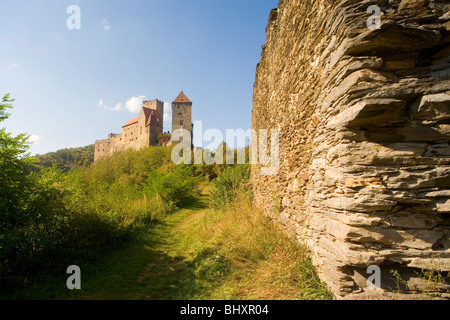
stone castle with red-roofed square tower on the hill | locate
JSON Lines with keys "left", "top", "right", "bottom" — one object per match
{"left": 94, "top": 91, "right": 192, "bottom": 161}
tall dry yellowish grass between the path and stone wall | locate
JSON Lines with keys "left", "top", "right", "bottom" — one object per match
{"left": 191, "top": 166, "right": 333, "bottom": 300}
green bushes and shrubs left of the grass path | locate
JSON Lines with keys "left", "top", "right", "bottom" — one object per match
{"left": 0, "top": 96, "right": 200, "bottom": 295}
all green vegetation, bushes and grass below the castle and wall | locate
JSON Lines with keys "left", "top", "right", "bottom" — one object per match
{"left": 0, "top": 96, "right": 332, "bottom": 299}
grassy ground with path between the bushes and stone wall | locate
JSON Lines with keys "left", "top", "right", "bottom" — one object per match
{"left": 2, "top": 185, "right": 332, "bottom": 300}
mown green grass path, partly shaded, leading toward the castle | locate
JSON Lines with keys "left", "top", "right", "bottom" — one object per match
{"left": 52, "top": 194, "right": 211, "bottom": 300}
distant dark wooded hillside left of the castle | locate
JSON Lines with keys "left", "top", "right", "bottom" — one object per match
{"left": 36, "top": 144, "right": 94, "bottom": 172}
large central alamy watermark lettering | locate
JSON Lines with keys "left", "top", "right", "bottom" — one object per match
{"left": 172, "top": 121, "right": 280, "bottom": 176}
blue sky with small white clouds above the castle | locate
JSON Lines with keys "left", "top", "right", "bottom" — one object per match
{"left": 0, "top": 0, "right": 278, "bottom": 154}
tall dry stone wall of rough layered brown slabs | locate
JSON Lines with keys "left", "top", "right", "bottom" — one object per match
{"left": 252, "top": 0, "right": 450, "bottom": 298}
